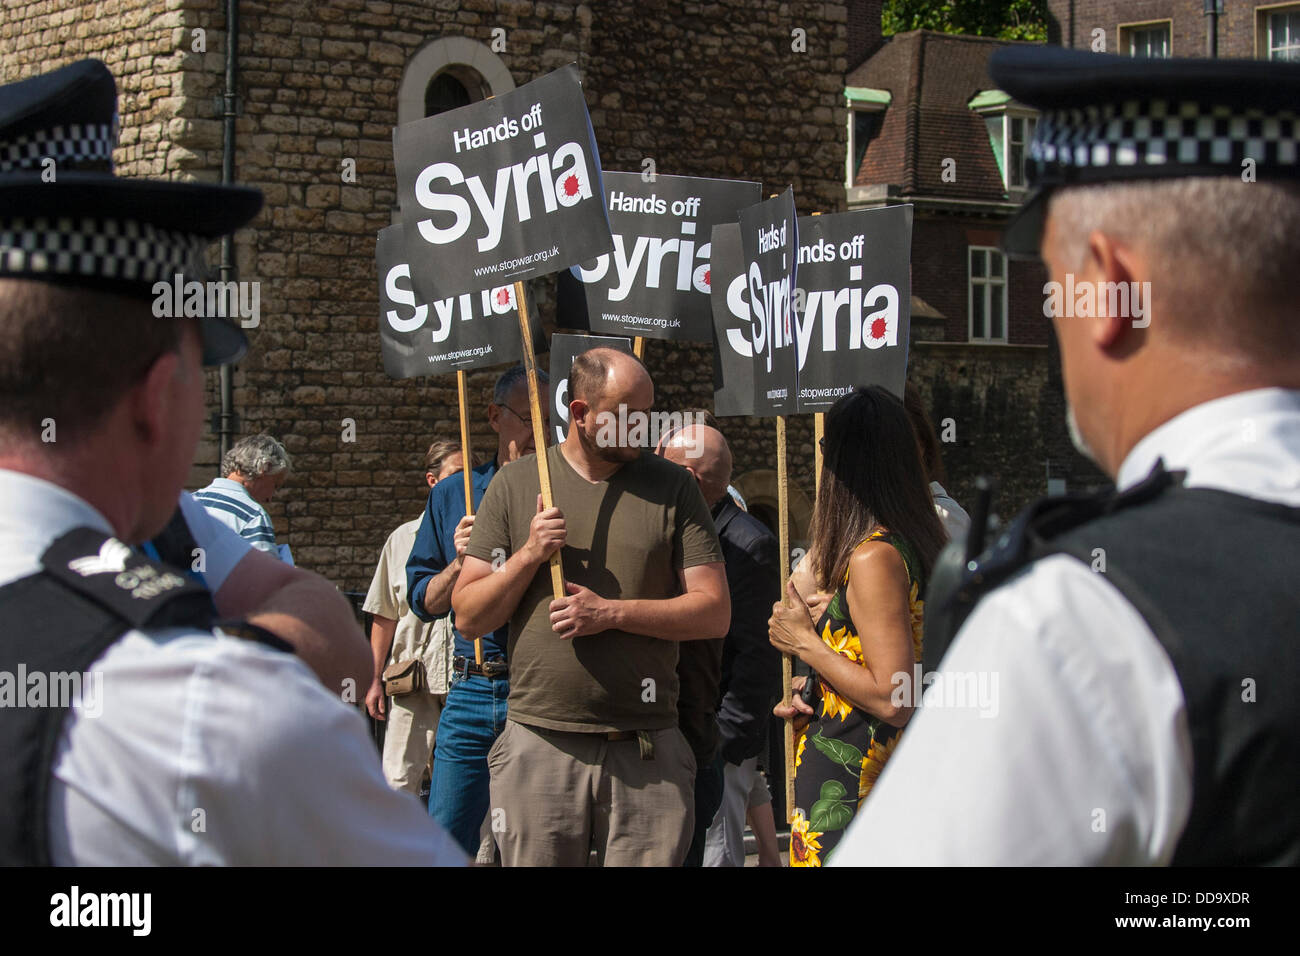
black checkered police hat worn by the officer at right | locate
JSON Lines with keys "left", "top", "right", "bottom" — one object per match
{"left": 989, "top": 47, "right": 1300, "bottom": 259}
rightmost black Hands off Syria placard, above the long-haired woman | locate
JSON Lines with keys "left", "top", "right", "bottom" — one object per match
{"left": 794, "top": 206, "right": 913, "bottom": 412}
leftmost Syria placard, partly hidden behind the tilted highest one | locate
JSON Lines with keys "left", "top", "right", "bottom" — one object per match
{"left": 374, "top": 224, "right": 542, "bottom": 378}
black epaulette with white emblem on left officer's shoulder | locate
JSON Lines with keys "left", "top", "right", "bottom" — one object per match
{"left": 40, "top": 528, "right": 216, "bottom": 628}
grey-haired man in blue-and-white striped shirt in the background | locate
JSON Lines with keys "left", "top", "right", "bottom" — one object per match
{"left": 194, "top": 434, "right": 293, "bottom": 554}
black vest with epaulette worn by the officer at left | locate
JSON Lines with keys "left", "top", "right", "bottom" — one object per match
{"left": 0, "top": 528, "right": 289, "bottom": 866}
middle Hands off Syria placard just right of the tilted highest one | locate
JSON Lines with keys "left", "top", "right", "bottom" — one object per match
{"left": 558, "top": 170, "right": 762, "bottom": 342}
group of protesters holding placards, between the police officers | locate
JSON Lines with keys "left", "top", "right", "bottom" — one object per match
{"left": 365, "top": 349, "right": 963, "bottom": 866}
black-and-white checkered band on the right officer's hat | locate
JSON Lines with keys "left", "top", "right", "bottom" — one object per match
{"left": 1030, "top": 100, "right": 1300, "bottom": 183}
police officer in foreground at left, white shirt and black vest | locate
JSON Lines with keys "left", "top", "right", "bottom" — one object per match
{"left": 0, "top": 61, "right": 464, "bottom": 865}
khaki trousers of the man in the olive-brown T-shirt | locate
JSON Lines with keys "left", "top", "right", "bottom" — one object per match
{"left": 488, "top": 719, "right": 696, "bottom": 866}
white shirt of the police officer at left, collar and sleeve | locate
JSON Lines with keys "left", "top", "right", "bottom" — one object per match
{"left": 0, "top": 470, "right": 465, "bottom": 865}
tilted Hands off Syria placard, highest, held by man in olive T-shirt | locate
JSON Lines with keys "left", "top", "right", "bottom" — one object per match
{"left": 393, "top": 64, "right": 614, "bottom": 300}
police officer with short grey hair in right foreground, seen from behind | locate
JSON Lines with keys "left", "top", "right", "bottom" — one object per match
{"left": 833, "top": 47, "right": 1300, "bottom": 865}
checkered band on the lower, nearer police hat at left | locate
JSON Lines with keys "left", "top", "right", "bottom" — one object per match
{"left": 0, "top": 217, "right": 207, "bottom": 282}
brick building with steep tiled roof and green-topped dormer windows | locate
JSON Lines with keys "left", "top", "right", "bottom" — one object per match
{"left": 845, "top": 1, "right": 1105, "bottom": 516}
